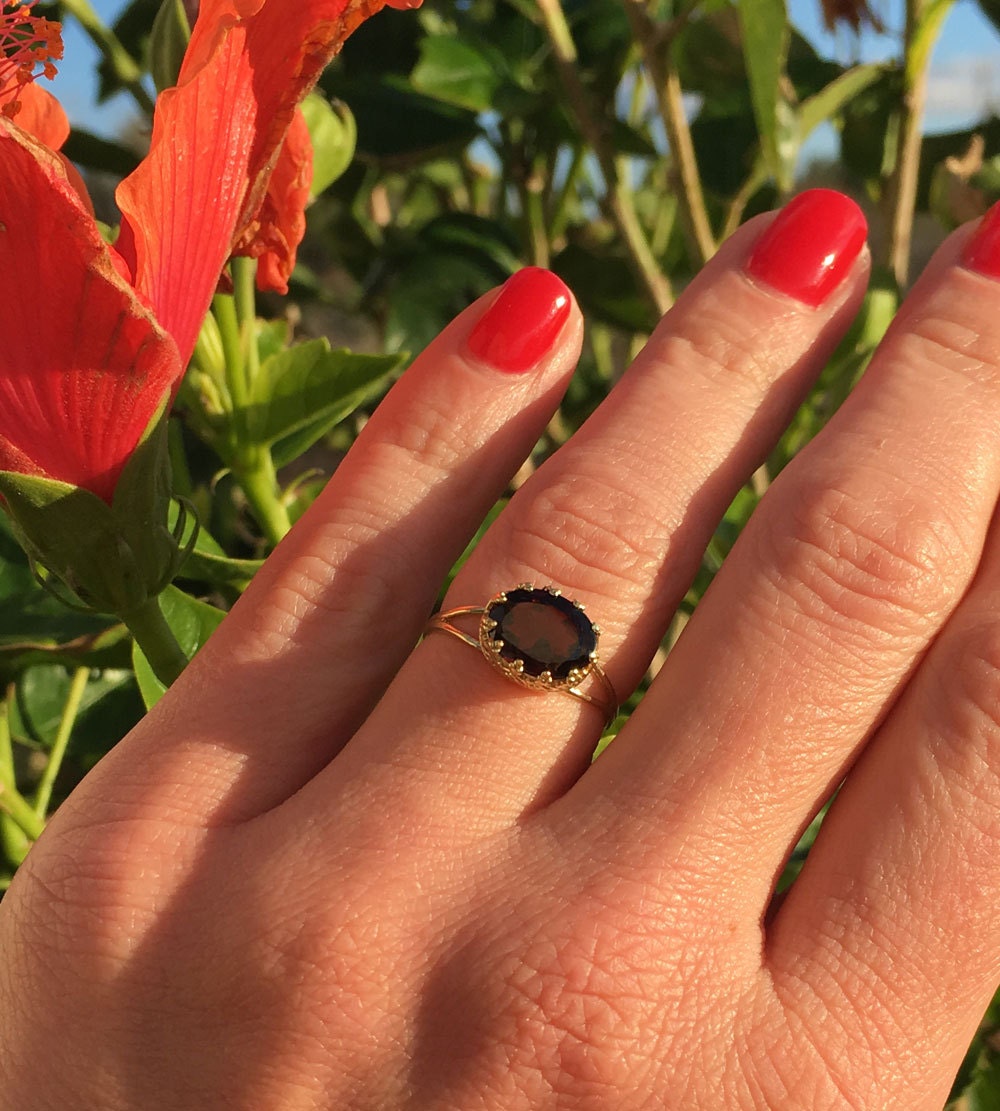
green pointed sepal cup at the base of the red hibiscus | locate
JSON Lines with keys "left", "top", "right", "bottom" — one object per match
{"left": 0, "top": 410, "right": 195, "bottom": 615}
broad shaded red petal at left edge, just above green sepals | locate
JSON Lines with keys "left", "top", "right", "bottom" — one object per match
{"left": 0, "top": 120, "right": 182, "bottom": 501}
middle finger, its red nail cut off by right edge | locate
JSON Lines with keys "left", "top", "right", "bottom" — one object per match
{"left": 577, "top": 209, "right": 1000, "bottom": 915}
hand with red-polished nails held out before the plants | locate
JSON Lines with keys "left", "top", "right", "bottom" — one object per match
{"left": 0, "top": 186, "right": 1000, "bottom": 1111}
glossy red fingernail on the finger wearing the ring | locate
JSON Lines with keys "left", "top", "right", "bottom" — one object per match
{"left": 747, "top": 189, "right": 868, "bottom": 309}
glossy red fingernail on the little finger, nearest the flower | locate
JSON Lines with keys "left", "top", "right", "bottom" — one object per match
{"left": 466, "top": 267, "right": 570, "bottom": 374}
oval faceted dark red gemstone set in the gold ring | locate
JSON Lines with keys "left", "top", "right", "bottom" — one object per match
{"left": 487, "top": 587, "right": 597, "bottom": 679}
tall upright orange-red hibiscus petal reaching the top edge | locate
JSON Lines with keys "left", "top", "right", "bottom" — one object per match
{"left": 118, "top": 0, "right": 411, "bottom": 360}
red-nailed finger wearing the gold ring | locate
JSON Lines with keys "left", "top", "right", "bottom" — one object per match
{"left": 313, "top": 191, "right": 866, "bottom": 828}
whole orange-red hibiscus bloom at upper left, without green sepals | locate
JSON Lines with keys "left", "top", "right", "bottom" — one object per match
{"left": 0, "top": 0, "right": 419, "bottom": 502}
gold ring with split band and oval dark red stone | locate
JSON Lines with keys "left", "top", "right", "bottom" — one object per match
{"left": 424, "top": 582, "right": 618, "bottom": 725}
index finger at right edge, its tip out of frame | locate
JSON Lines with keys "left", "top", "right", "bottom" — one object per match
{"left": 768, "top": 511, "right": 1000, "bottom": 1111}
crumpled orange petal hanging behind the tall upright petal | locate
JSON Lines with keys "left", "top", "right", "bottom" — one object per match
{"left": 232, "top": 109, "right": 312, "bottom": 293}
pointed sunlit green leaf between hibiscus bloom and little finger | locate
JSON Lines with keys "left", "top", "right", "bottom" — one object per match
{"left": 248, "top": 338, "right": 402, "bottom": 467}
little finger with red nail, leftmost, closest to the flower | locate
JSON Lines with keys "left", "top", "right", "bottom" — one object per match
{"left": 80, "top": 269, "right": 581, "bottom": 821}
